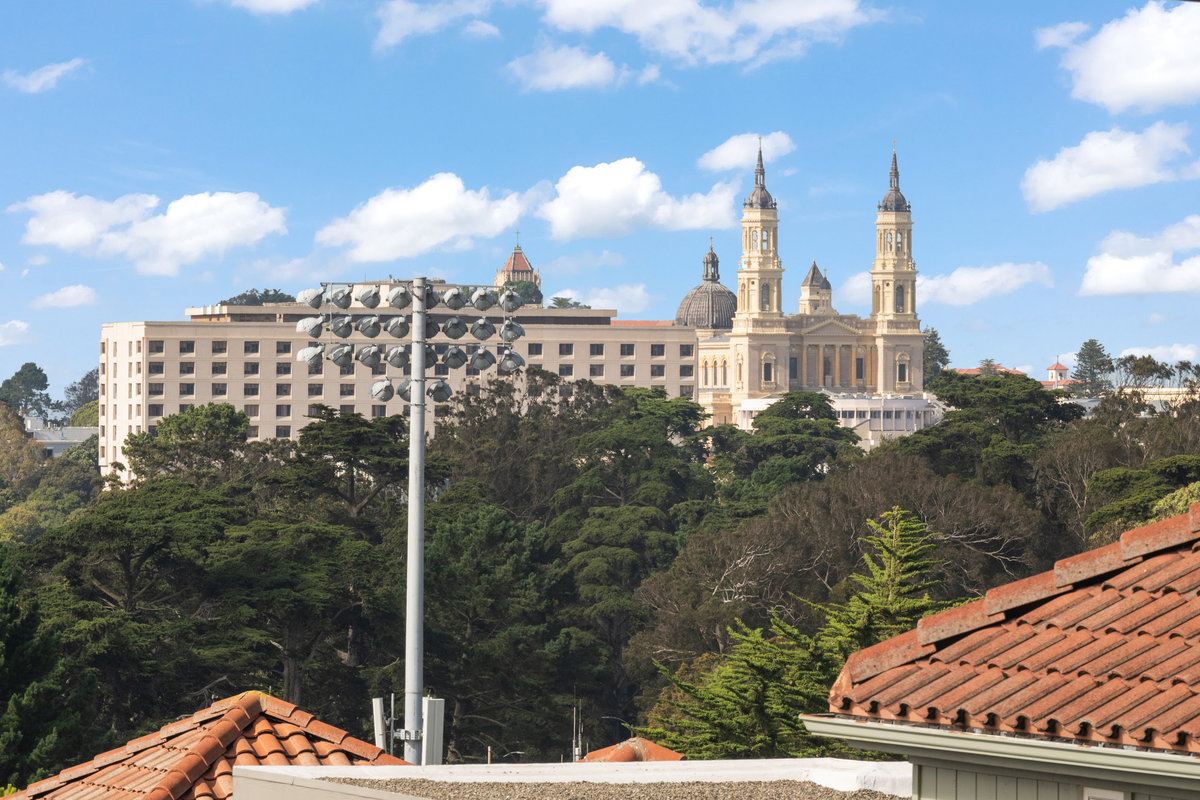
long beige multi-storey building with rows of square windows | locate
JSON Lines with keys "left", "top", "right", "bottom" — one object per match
{"left": 100, "top": 303, "right": 696, "bottom": 473}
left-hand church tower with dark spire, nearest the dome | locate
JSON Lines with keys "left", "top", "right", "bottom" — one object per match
{"left": 733, "top": 142, "right": 784, "bottom": 327}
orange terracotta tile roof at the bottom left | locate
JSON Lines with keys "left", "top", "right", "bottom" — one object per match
{"left": 11, "top": 692, "right": 407, "bottom": 800}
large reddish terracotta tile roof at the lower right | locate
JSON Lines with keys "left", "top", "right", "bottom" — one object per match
{"left": 829, "top": 504, "right": 1200, "bottom": 754}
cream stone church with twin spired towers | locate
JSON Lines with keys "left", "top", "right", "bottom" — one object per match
{"left": 676, "top": 152, "right": 926, "bottom": 439}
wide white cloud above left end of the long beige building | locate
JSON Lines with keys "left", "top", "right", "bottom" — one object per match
{"left": 8, "top": 191, "right": 287, "bottom": 276}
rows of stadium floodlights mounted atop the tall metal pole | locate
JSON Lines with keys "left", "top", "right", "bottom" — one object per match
{"left": 296, "top": 284, "right": 524, "bottom": 403}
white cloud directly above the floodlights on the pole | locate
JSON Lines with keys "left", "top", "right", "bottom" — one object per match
{"left": 317, "top": 173, "right": 529, "bottom": 261}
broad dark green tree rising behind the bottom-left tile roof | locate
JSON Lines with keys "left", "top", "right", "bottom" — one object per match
{"left": 28, "top": 481, "right": 244, "bottom": 743}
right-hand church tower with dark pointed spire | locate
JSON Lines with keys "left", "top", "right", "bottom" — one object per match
{"left": 871, "top": 148, "right": 917, "bottom": 323}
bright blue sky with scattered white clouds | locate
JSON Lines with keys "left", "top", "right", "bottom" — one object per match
{"left": 0, "top": 0, "right": 1200, "bottom": 392}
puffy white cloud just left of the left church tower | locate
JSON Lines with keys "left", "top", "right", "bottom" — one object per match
{"left": 538, "top": 158, "right": 736, "bottom": 239}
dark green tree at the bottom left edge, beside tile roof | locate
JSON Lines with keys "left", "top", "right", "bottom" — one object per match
{"left": 0, "top": 545, "right": 84, "bottom": 786}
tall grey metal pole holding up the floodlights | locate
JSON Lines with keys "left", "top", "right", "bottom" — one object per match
{"left": 403, "top": 278, "right": 425, "bottom": 764}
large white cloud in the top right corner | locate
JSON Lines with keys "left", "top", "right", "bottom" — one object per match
{"left": 1036, "top": 0, "right": 1200, "bottom": 113}
